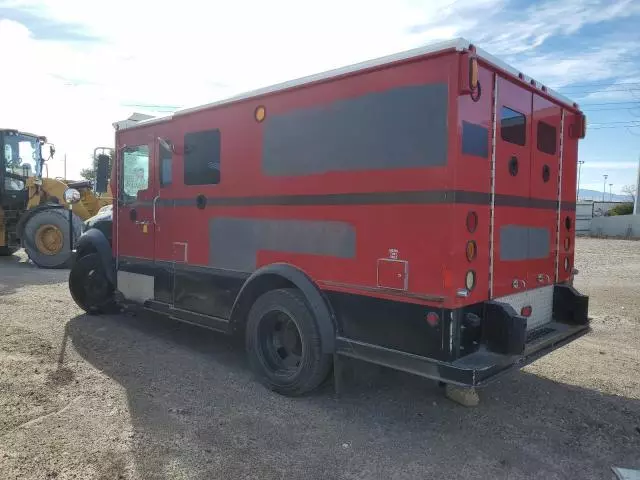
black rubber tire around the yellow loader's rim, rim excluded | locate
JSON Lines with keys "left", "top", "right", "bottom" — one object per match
{"left": 22, "top": 208, "right": 82, "bottom": 268}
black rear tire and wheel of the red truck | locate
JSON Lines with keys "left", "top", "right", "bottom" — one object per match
{"left": 245, "top": 289, "right": 333, "bottom": 396}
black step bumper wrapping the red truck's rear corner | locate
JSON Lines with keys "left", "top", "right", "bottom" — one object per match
{"left": 336, "top": 322, "right": 590, "bottom": 387}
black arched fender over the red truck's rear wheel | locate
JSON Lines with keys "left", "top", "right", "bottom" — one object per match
{"left": 231, "top": 263, "right": 336, "bottom": 353}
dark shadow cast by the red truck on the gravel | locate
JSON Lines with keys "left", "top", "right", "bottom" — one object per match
{"left": 65, "top": 315, "right": 640, "bottom": 479}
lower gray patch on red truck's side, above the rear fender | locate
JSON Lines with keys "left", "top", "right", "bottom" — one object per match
{"left": 209, "top": 217, "right": 356, "bottom": 272}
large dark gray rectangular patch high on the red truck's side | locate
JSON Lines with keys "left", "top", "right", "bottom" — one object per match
{"left": 262, "top": 83, "right": 449, "bottom": 176}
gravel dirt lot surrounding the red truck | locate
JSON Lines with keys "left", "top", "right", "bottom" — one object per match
{"left": 0, "top": 239, "right": 640, "bottom": 480}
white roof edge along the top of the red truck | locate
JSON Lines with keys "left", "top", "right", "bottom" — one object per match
{"left": 113, "top": 37, "right": 577, "bottom": 130}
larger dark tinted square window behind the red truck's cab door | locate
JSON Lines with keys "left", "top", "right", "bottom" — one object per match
{"left": 184, "top": 130, "right": 220, "bottom": 185}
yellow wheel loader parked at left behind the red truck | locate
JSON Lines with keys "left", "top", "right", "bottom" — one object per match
{"left": 0, "top": 129, "right": 112, "bottom": 268}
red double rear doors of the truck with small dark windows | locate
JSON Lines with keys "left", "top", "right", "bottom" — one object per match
{"left": 491, "top": 77, "right": 562, "bottom": 329}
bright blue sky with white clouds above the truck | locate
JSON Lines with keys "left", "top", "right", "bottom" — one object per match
{"left": 0, "top": 0, "right": 640, "bottom": 193}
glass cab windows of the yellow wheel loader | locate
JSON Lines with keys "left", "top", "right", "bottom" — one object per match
{"left": 3, "top": 134, "right": 42, "bottom": 190}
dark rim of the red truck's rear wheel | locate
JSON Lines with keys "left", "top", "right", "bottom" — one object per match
{"left": 258, "top": 311, "right": 303, "bottom": 377}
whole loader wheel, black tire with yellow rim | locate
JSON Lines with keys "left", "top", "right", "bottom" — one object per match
{"left": 22, "top": 208, "right": 82, "bottom": 268}
